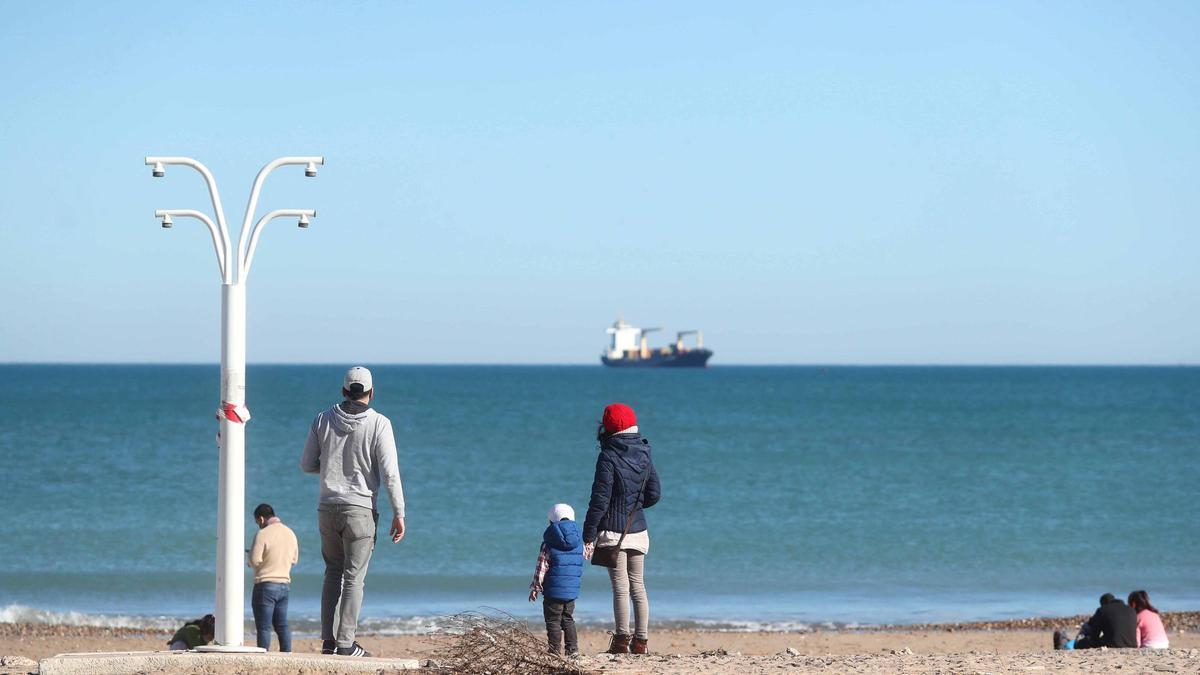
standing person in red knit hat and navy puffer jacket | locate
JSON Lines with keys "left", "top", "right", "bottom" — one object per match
{"left": 583, "top": 404, "right": 661, "bottom": 653}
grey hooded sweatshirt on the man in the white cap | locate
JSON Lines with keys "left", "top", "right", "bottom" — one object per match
{"left": 300, "top": 405, "right": 404, "bottom": 518}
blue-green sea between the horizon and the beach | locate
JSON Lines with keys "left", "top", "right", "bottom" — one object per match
{"left": 0, "top": 364, "right": 1200, "bottom": 632}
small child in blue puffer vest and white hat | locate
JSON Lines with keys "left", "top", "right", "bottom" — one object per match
{"left": 529, "top": 504, "right": 583, "bottom": 656}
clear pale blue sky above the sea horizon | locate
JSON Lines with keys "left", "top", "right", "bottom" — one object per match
{"left": 0, "top": 2, "right": 1200, "bottom": 365}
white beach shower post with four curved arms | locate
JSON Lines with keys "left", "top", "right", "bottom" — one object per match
{"left": 146, "top": 157, "right": 325, "bottom": 651}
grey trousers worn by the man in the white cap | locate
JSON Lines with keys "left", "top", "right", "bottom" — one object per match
{"left": 317, "top": 504, "right": 379, "bottom": 647}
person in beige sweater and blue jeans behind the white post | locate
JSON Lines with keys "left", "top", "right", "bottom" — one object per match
{"left": 250, "top": 504, "right": 300, "bottom": 651}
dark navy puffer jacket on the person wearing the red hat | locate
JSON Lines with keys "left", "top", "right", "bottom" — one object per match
{"left": 583, "top": 434, "right": 661, "bottom": 542}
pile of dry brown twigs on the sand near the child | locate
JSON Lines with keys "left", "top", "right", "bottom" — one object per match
{"left": 434, "top": 610, "right": 584, "bottom": 675}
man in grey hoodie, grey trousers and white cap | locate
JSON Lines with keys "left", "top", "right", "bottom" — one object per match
{"left": 300, "top": 366, "right": 404, "bottom": 656}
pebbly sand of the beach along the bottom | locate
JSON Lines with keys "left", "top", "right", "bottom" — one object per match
{"left": 0, "top": 613, "right": 1200, "bottom": 675}
